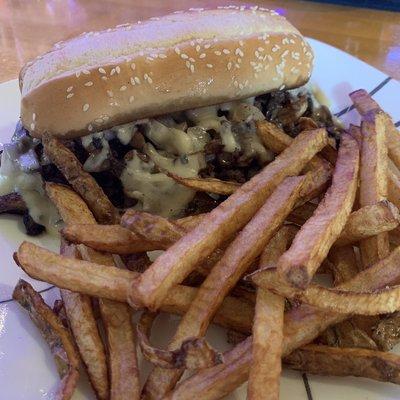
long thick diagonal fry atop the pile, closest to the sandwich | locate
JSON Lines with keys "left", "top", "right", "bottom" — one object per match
{"left": 129, "top": 130, "right": 327, "bottom": 310}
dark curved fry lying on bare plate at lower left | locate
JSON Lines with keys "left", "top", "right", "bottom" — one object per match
{"left": 13, "top": 279, "right": 79, "bottom": 400}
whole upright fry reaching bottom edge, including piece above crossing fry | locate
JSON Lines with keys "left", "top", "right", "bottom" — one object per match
{"left": 247, "top": 225, "right": 297, "bottom": 399}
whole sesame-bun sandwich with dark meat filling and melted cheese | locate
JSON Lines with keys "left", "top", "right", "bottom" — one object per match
{"left": 0, "top": 6, "right": 340, "bottom": 235}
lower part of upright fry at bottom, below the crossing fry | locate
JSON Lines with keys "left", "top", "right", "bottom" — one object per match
{"left": 247, "top": 288, "right": 285, "bottom": 400}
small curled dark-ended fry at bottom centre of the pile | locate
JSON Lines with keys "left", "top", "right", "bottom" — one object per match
{"left": 136, "top": 312, "right": 223, "bottom": 370}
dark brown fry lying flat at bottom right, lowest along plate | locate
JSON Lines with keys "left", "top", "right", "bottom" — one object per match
{"left": 284, "top": 345, "right": 400, "bottom": 384}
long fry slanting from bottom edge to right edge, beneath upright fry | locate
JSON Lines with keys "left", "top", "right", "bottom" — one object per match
{"left": 168, "top": 248, "right": 400, "bottom": 400}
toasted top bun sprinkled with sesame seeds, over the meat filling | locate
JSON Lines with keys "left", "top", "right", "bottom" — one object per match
{"left": 20, "top": 6, "right": 313, "bottom": 138}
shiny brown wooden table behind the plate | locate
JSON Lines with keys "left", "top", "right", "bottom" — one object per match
{"left": 0, "top": 0, "right": 400, "bottom": 82}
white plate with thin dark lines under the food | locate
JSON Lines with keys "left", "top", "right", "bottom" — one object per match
{"left": 0, "top": 39, "right": 400, "bottom": 400}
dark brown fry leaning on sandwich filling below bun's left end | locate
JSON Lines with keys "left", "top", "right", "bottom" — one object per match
{"left": 42, "top": 134, "right": 119, "bottom": 224}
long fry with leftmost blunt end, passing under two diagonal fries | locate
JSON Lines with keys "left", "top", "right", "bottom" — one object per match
{"left": 14, "top": 242, "right": 254, "bottom": 333}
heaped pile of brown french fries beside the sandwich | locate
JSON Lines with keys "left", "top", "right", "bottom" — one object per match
{"left": 14, "top": 90, "right": 400, "bottom": 400}
